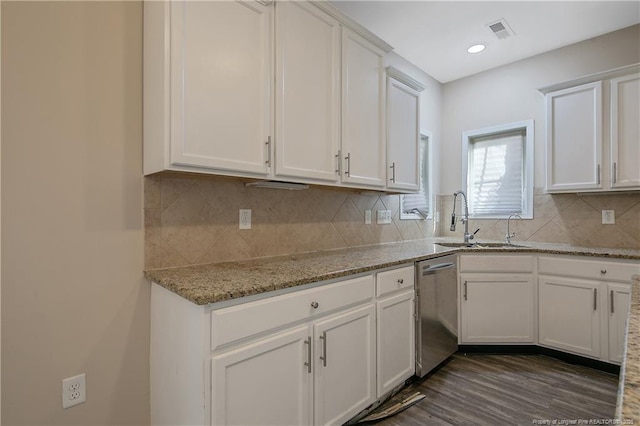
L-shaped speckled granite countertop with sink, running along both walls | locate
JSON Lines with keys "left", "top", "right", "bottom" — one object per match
{"left": 145, "top": 238, "right": 640, "bottom": 305}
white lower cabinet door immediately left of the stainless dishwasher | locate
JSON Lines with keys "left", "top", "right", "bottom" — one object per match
{"left": 376, "top": 290, "right": 416, "bottom": 398}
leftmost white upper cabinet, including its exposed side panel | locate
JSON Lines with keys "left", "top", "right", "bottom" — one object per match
{"left": 144, "top": 1, "right": 273, "bottom": 176}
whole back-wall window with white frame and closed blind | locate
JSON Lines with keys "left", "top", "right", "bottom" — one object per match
{"left": 462, "top": 120, "right": 533, "bottom": 219}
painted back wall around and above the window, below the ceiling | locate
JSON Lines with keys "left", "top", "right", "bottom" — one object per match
{"left": 440, "top": 25, "right": 640, "bottom": 194}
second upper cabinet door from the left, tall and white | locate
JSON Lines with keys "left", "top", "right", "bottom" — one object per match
{"left": 275, "top": 2, "right": 340, "bottom": 182}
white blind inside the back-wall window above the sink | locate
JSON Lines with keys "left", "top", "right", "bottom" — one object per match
{"left": 467, "top": 129, "right": 526, "bottom": 216}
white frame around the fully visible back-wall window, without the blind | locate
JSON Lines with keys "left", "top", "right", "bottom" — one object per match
{"left": 462, "top": 119, "right": 534, "bottom": 219}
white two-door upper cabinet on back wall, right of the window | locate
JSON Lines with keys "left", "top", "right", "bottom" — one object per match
{"left": 540, "top": 65, "right": 640, "bottom": 192}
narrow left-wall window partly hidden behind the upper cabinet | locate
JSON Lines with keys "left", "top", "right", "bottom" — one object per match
{"left": 400, "top": 132, "right": 432, "bottom": 219}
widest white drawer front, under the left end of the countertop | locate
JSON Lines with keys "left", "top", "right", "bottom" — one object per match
{"left": 211, "top": 275, "right": 373, "bottom": 351}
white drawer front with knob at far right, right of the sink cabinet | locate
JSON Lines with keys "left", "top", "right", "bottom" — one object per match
{"left": 538, "top": 256, "right": 640, "bottom": 283}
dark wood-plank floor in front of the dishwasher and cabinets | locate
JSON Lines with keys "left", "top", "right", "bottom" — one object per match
{"left": 376, "top": 354, "right": 618, "bottom": 426}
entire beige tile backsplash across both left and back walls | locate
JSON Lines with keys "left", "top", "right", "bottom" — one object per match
{"left": 144, "top": 174, "right": 640, "bottom": 269}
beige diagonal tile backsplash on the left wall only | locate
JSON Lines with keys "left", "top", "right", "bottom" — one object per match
{"left": 144, "top": 175, "right": 434, "bottom": 269}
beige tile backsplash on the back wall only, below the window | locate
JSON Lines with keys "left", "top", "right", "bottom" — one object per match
{"left": 436, "top": 189, "right": 640, "bottom": 249}
